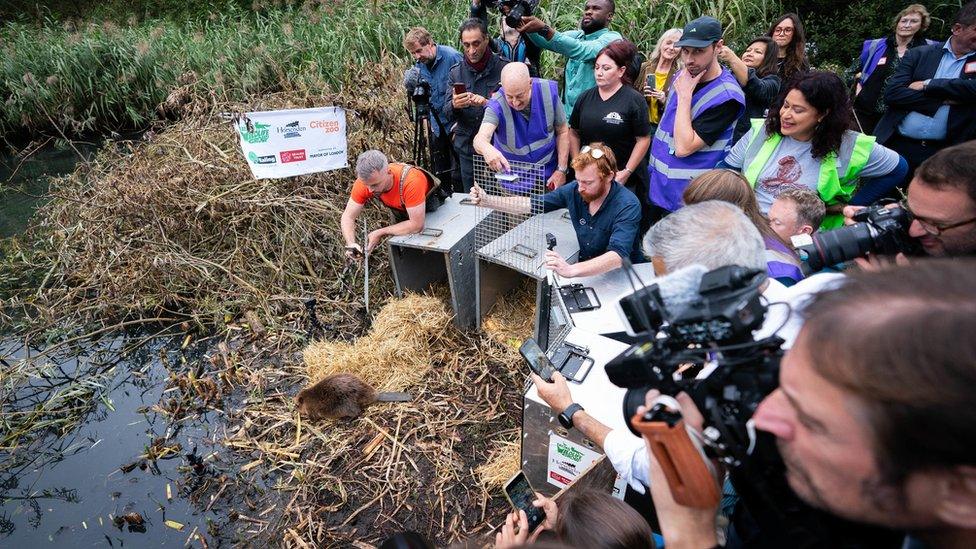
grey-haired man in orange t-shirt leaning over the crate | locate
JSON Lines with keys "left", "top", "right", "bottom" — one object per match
{"left": 339, "top": 150, "right": 430, "bottom": 259}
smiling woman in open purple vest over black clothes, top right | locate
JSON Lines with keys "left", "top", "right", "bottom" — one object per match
{"left": 848, "top": 4, "right": 936, "bottom": 134}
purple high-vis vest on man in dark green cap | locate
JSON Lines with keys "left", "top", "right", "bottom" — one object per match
{"left": 648, "top": 69, "right": 746, "bottom": 212}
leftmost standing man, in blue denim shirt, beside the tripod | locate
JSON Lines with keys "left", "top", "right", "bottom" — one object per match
{"left": 403, "top": 27, "right": 461, "bottom": 191}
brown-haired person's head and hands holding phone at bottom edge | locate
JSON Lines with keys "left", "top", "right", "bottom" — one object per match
{"left": 495, "top": 490, "right": 657, "bottom": 549}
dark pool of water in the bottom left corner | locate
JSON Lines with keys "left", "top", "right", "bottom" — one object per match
{"left": 0, "top": 339, "right": 232, "bottom": 547}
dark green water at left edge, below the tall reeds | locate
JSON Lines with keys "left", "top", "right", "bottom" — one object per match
{"left": 0, "top": 142, "right": 98, "bottom": 238}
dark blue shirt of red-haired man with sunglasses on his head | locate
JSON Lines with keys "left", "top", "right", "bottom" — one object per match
{"left": 532, "top": 181, "right": 644, "bottom": 263}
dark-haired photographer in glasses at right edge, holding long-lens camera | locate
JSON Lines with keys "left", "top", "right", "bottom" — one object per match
{"left": 844, "top": 141, "right": 976, "bottom": 269}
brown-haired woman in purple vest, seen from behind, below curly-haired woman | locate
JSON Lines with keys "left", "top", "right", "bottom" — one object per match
{"left": 682, "top": 169, "right": 803, "bottom": 286}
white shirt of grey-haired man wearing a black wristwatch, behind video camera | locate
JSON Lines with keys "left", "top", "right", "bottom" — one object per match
{"left": 603, "top": 273, "right": 844, "bottom": 494}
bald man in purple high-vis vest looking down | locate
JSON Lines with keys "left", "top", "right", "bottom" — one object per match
{"left": 474, "top": 63, "right": 569, "bottom": 194}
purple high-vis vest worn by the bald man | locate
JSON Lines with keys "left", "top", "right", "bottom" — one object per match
{"left": 487, "top": 78, "right": 559, "bottom": 193}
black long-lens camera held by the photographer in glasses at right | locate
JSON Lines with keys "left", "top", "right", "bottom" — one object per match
{"left": 793, "top": 201, "right": 919, "bottom": 272}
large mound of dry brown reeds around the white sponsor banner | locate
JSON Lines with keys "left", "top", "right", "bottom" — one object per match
{"left": 0, "top": 54, "right": 411, "bottom": 326}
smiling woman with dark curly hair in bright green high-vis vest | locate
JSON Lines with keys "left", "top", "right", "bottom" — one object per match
{"left": 719, "top": 71, "right": 908, "bottom": 229}
